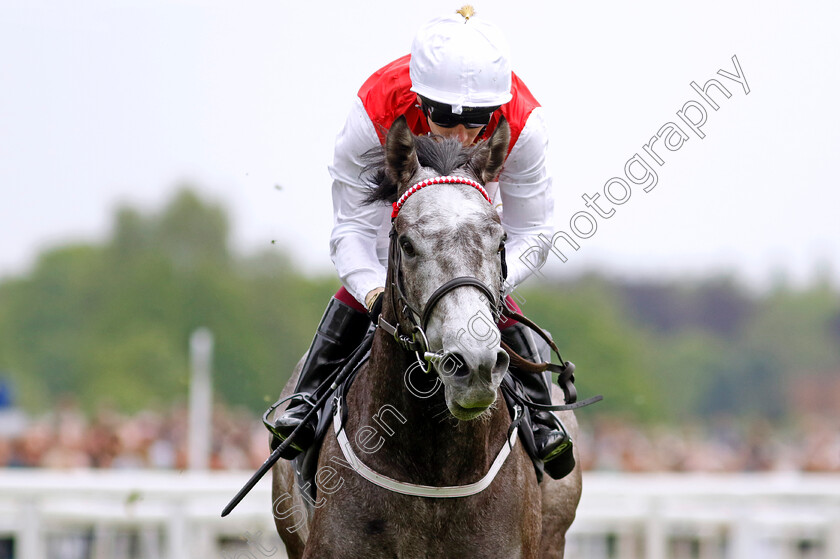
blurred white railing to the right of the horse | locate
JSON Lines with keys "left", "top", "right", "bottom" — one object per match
{"left": 569, "top": 474, "right": 840, "bottom": 559}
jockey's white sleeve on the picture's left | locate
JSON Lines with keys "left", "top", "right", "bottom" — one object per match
{"left": 329, "top": 97, "right": 390, "bottom": 305}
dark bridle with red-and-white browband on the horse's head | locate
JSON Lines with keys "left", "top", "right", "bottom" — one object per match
{"left": 378, "top": 175, "right": 507, "bottom": 373}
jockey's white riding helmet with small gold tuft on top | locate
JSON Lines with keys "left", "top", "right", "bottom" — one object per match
{"left": 409, "top": 6, "right": 512, "bottom": 114}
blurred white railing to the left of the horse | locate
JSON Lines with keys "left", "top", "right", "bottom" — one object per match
{"left": 0, "top": 470, "right": 285, "bottom": 559}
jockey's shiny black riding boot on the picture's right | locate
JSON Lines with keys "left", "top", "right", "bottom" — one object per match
{"left": 501, "top": 323, "right": 575, "bottom": 479}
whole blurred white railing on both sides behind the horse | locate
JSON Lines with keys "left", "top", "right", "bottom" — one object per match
{"left": 0, "top": 469, "right": 840, "bottom": 559}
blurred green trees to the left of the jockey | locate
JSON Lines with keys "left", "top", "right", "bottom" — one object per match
{"left": 0, "top": 189, "right": 338, "bottom": 411}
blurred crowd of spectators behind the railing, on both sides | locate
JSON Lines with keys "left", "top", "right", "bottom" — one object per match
{"left": 0, "top": 401, "right": 840, "bottom": 472}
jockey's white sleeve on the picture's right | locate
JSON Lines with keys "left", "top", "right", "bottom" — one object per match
{"left": 499, "top": 107, "right": 554, "bottom": 292}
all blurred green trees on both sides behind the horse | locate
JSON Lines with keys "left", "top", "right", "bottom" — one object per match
{"left": 0, "top": 187, "right": 840, "bottom": 421}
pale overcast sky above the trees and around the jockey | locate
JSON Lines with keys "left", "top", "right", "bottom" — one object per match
{"left": 0, "top": 0, "right": 840, "bottom": 294}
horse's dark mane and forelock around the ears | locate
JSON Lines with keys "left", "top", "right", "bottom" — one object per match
{"left": 361, "top": 136, "right": 477, "bottom": 204}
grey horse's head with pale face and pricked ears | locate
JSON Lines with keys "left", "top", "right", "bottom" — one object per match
{"left": 371, "top": 118, "right": 510, "bottom": 420}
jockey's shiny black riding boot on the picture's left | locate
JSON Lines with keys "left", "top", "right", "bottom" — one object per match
{"left": 271, "top": 297, "right": 370, "bottom": 459}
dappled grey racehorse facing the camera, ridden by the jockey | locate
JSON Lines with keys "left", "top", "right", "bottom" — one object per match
{"left": 272, "top": 119, "right": 581, "bottom": 559}
